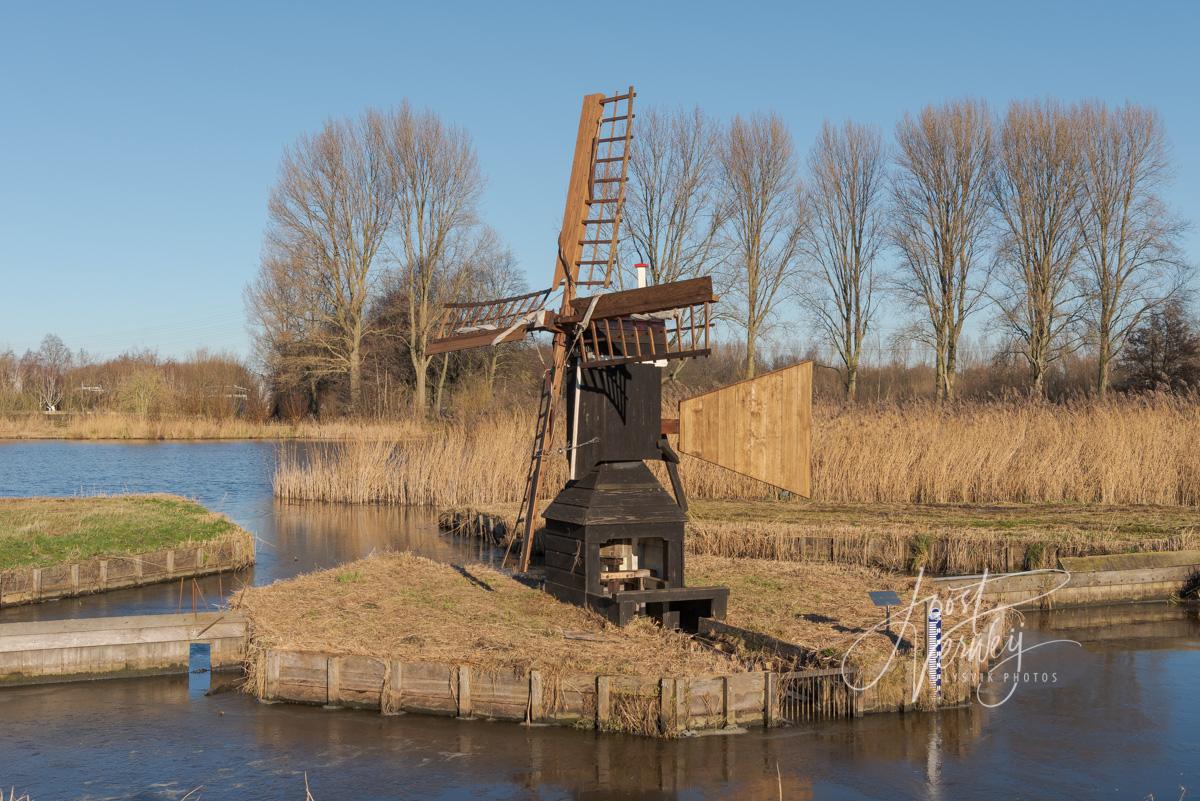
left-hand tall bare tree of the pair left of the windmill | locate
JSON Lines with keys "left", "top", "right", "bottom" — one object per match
{"left": 247, "top": 112, "right": 395, "bottom": 410}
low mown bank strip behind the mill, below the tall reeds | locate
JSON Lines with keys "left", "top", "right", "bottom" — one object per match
{"left": 439, "top": 500, "right": 1200, "bottom": 576}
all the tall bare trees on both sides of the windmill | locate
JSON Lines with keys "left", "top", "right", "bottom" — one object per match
{"left": 247, "top": 100, "right": 1186, "bottom": 414}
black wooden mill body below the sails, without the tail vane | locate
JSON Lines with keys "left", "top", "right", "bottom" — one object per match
{"left": 544, "top": 330, "right": 728, "bottom": 632}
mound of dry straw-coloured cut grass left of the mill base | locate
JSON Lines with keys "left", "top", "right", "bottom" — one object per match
{"left": 235, "top": 553, "right": 740, "bottom": 676}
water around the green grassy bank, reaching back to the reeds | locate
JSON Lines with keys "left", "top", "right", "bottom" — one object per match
{"left": 0, "top": 441, "right": 494, "bottom": 622}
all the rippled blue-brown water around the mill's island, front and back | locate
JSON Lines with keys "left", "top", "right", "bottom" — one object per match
{"left": 0, "top": 442, "right": 1200, "bottom": 801}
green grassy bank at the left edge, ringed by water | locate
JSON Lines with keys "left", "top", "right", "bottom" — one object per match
{"left": 0, "top": 495, "right": 250, "bottom": 570}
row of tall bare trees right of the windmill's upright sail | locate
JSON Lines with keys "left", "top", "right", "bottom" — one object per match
{"left": 626, "top": 100, "right": 1187, "bottom": 398}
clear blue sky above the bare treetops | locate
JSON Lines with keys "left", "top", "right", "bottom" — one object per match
{"left": 0, "top": 0, "right": 1200, "bottom": 355}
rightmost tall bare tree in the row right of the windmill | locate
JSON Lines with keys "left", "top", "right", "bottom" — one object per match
{"left": 1080, "top": 103, "right": 1184, "bottom": 397}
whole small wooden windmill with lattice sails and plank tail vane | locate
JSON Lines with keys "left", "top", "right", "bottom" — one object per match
{"left": 428, "top": 86, "right": 811, "bottom": 631}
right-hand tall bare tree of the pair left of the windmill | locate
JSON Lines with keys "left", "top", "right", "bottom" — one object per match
{"left": 385, "top": 104, "right": 484, "bottom": 415}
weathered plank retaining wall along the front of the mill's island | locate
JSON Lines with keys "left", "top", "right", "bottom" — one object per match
{"left": 257, "top": 649, "right": 862, "bottom": 737}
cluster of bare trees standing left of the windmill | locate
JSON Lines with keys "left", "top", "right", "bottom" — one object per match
{"left": 247, "top": 103, "right": 520, "bottom": 414}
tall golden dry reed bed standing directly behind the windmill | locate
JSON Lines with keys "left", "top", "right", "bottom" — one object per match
{"left": 275, "top": 399, "right": 1200, "bottom": 506}
